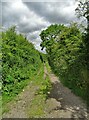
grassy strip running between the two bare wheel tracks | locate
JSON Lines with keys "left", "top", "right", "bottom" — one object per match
{"left": 27, "top": 63, "right": 51, "bottom": 118}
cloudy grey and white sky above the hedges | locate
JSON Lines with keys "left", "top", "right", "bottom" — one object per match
{"left": 1, "top": 0, "right": 78, "bottom": 50}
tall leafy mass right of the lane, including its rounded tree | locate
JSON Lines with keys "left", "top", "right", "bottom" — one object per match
{"left": 40, "top": 23, "right": 88, "bottom": 104}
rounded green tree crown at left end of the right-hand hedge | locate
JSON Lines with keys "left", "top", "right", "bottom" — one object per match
{"left": 40, "top": 24, "right": 64, "bottom": 51}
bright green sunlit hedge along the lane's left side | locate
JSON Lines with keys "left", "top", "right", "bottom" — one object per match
{"left": 2, "top": 27, "right": 42, "bottom": 103}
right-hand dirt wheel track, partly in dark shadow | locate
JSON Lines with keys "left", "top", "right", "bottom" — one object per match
{"left": 45, "top": 73, "right": 89, "bottom": 120}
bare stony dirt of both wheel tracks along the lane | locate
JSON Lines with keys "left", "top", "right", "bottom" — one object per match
{"left": 3, "top": 66, "right": 89, "bottom": 120}
